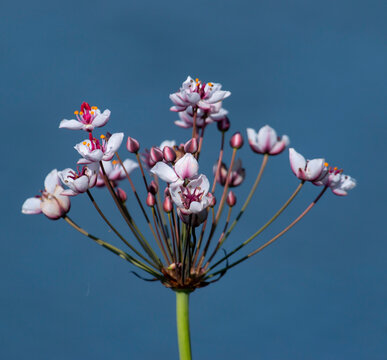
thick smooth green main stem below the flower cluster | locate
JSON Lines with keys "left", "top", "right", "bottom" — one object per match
{"left": 175, "top": 290, "right": 192, "bottom": 360}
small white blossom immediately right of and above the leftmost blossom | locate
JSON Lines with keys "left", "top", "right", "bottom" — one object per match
{"left": 58, "top": 163, "right": 99, "bottom": 196}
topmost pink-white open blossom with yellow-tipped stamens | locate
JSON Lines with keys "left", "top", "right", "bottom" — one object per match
{"left": 169, "top": 76, "right": 231, "bottom": 112}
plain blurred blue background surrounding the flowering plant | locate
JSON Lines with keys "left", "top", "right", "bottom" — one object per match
{"left": 0, "top": 0, "right": 387, "bottom": 360}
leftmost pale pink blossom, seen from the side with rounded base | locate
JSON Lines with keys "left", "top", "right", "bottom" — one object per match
{"left": 22, "top": 169, "right": 71, "bottom": 220}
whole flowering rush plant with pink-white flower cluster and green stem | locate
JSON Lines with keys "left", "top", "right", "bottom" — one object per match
{"left": 22, "top": 77, "right": 356, "bottom": 360}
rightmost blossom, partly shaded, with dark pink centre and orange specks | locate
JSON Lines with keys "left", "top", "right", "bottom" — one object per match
{"left": 313, "top": 163, "right": 356, "bottom": 196}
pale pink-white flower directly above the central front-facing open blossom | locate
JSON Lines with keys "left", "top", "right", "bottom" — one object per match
{"left": 150, "top": 154, "right": 199, "bottom": 185}
